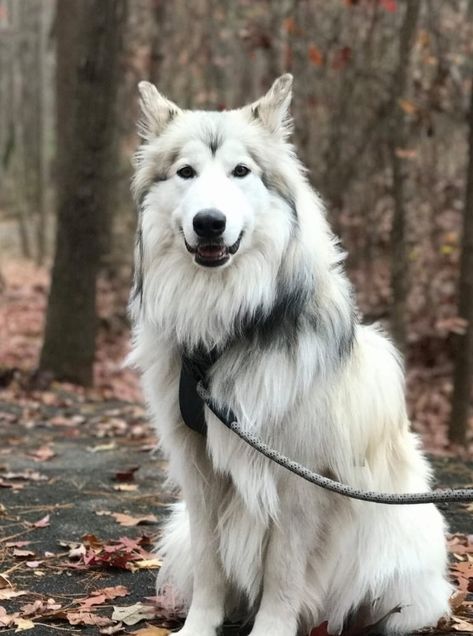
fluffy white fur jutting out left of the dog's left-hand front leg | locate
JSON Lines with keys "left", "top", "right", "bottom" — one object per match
{"left": 156, "top": 501, "right": 193, "bottom": 607}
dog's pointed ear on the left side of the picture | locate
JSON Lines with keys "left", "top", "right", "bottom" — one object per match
{"left": 138, "top": 82, "right": 182, "bottom": 141}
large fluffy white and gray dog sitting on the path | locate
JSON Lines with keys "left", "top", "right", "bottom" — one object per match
{"left": 130, "top": 75, "right": 451, "bottom": 636}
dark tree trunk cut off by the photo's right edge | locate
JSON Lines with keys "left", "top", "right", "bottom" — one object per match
{"left": 449, "top": 82, "right": 473, "bottom": 444}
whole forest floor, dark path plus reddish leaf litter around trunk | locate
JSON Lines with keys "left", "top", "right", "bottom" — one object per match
{"left": 0, "top": 263, "right": 473, "bottom": 636}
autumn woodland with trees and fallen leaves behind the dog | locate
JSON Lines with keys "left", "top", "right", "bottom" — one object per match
{"left": 0, "top": 0, "right": 473, "bottom": 453}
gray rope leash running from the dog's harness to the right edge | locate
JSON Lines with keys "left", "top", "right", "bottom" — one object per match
{"left": 197, "top": 382, "right": 473, "bottom": 505}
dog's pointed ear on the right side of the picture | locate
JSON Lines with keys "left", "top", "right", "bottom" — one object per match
{"left": 246, "top": 73, "right": 293, "bottom": 137}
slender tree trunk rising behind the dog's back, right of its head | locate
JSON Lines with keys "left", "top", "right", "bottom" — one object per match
{"left": 390, "top": 0, "right": 420, "bottom": 351}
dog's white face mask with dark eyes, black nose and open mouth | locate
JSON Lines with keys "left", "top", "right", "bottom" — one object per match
{"left": 155, "top": 126, "right": 268, "bottom": 267}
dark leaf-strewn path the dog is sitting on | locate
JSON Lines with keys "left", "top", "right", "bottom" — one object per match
{"left": 0, "top": 391, "right": 473, "bottom": 636}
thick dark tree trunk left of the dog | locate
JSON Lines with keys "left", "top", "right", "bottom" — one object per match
{"left": 40, "top": 0, "right": 126, "bottom": 385}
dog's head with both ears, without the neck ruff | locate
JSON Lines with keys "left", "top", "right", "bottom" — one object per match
{"left": 131, "top": 75, "right": 294, "bottom": 269}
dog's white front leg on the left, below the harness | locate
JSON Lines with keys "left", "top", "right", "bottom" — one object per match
{"left": 173, "top": 448, "right": 226, "bottom": 636}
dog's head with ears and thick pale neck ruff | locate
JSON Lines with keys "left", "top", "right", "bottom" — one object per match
{"left": 130, "top": 75, "right": 350, "bottom": 356}
